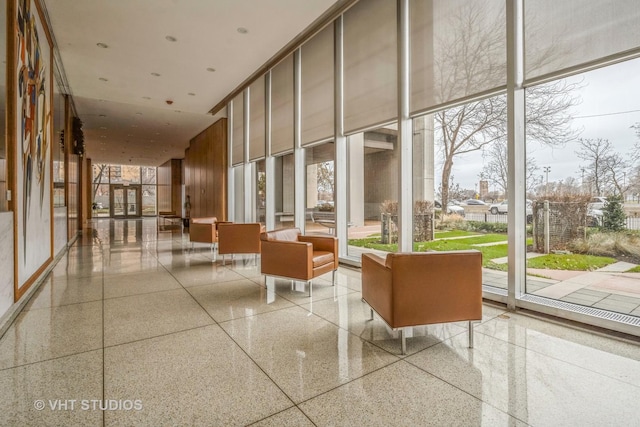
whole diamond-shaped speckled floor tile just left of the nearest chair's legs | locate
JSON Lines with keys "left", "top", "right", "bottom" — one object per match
{"left": 220, "top": 307, "right": 397, "bottom": 402}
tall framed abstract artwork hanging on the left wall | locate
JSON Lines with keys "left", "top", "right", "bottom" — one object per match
{"left": 14, "top": 0, "right": 53, "bottom": 294}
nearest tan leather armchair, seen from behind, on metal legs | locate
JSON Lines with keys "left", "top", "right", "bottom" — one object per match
{"left": 362, "top": 250, "right": 482, "bottom": 354}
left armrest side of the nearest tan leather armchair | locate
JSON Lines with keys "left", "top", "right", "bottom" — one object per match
{"left": 362, "top": 253, "right": 394, "bottom": 327}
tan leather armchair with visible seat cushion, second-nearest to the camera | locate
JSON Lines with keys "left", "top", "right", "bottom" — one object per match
{"left": 260, "top": 228, "right": 338, "bottom": 296}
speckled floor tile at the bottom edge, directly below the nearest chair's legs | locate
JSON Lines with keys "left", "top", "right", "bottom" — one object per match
{"left": 299, "top": 361, "right": 526, "bottom": 426}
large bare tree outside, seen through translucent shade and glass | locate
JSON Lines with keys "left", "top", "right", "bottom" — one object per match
{"left": 434, "top": 2, "right": 581, "bottom": 210}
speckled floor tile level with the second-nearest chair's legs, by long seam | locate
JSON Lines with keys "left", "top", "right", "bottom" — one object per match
{"left": 104, "top": 271, "right": 182, "bottom": 298}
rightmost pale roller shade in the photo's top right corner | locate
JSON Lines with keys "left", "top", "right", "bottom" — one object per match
{"left": 524, "top": 0, "right": 640, "bottom": 79}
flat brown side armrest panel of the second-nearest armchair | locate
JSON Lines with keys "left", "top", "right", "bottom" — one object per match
{"left": 260, "top": 240, "right": 313, "bottom": 280}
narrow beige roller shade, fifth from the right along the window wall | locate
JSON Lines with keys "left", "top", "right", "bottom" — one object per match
{"left": 271, "top": 55, "right": 293, "bottom": 154}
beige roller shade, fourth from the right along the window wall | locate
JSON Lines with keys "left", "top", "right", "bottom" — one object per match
{"left": 301, "top": 25, "right": 334, "bottom": 145}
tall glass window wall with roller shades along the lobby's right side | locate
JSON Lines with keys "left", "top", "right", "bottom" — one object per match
{"left": 224, "top": 0, "right": 640, "bottom": 331}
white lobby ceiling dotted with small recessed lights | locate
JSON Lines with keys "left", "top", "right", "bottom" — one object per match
{"left": 44, "top": 0, "right": 340, "bottom": 166}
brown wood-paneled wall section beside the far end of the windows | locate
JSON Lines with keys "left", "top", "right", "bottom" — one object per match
{"left": 184, "top": 119, "right": 228, "bottom": 221}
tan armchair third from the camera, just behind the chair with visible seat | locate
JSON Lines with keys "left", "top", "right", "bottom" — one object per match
{"left": 218, "top": 222, "right": 264, "bottom": 264}
